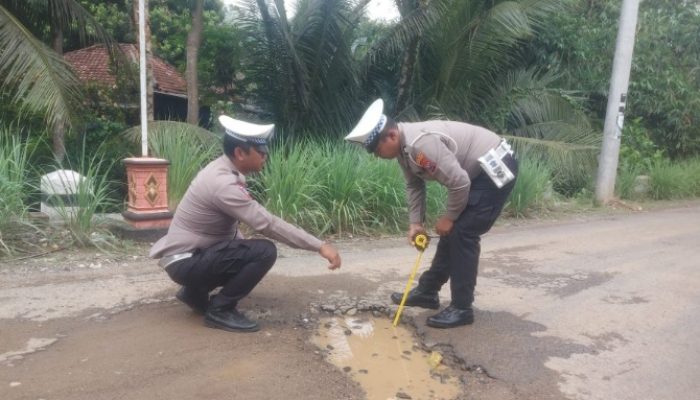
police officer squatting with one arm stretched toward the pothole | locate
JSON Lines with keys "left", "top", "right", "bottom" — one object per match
{"left": 150, "top": 116, "right": 341, "bottom": 331}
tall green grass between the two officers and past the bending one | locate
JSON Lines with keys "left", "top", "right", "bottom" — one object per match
{"left": 252, "top": 141, "right": 568, "bottom": 234}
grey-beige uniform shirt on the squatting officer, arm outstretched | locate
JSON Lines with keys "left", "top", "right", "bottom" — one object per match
{"left": 150, "top": 155, "right": 323, "bottom": 258}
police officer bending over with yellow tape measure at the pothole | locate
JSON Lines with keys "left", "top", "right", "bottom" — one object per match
{"left": 345, "top": 99, "right": 518, "bottom": 328}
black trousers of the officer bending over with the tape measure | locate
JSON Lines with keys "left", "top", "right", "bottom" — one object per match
{"left": 418, "top": 156, "right": 518, "bottom": 308}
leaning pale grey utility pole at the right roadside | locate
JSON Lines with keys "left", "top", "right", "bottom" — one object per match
{"left": 595, "top": 0, "right": 640, "bottom": 205}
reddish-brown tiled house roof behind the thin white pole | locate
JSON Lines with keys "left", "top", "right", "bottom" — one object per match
{"left": 63, "top": 43, "right": 187, "bottom": 96}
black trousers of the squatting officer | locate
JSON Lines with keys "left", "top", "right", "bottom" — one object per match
{"left": 166, "top": 239, "right": 277, "bottom": 309}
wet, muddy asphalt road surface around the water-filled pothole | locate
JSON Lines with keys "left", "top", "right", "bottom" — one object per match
{"left": 0, "top": 202, "right": 700, "bottom": 400}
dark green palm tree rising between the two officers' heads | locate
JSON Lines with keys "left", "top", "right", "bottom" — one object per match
{"left": 240, "top": 0, "right": 368, "bottom": 135}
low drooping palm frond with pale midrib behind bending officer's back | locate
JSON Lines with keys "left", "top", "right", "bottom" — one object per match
{"left": 426, "top": 64, "right": 601, "bottom": 185}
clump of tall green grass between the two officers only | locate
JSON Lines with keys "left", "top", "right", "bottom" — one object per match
{"left": 254, "top": 141, "right": 405, "bottom": 234}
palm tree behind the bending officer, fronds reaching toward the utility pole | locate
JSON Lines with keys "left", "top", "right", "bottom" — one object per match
{"left": 364, "top": 0, "right": 600, "bottom": 192}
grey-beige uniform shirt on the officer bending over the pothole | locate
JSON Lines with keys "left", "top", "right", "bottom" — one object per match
{"left": 398, "top": 121, "right": 501, "bottom": 223}
